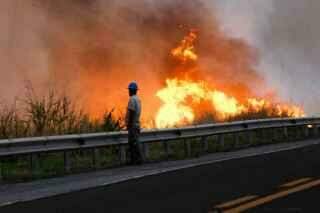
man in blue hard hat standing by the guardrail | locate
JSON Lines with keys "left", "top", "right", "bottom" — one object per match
{"left": 126, "top": 82, "right": 142, "bottom": 164}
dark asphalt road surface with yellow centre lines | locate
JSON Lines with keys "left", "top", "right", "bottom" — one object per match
{"left": 0, "top": 141, "right": 320, "bottom": 213}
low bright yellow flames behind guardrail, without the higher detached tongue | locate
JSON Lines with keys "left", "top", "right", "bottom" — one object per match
{"left": 156, "top": 79, "right": 304, "bottom": 128}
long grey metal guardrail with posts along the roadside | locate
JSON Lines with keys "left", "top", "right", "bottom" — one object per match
{"left": 0, "top": 118, "right": 320, "bottom": 179}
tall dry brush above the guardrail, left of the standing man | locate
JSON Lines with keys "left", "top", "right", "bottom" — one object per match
{"left": 0, "top": 89, "right": 122, "bottom": 139}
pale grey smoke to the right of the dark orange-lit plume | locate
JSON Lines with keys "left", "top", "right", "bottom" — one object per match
{"left": 216, "top": 0, "right": 320, "bottom": 115}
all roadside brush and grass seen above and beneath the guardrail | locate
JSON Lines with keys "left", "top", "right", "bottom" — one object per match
{"left": 0, "top": 90, "right": 303, "bottom": 182}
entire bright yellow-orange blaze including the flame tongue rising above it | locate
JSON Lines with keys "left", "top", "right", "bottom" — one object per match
{"left": 155, "top": 30, "right": 304, "bottom": 128}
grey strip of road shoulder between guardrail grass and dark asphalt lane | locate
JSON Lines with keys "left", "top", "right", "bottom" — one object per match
{"left": 0, "top": 139, "right": 320, "bottom": 206}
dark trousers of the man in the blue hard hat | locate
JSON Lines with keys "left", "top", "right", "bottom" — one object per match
{"left": 128, "top": 127, "right": 142, "bottom": 164}
